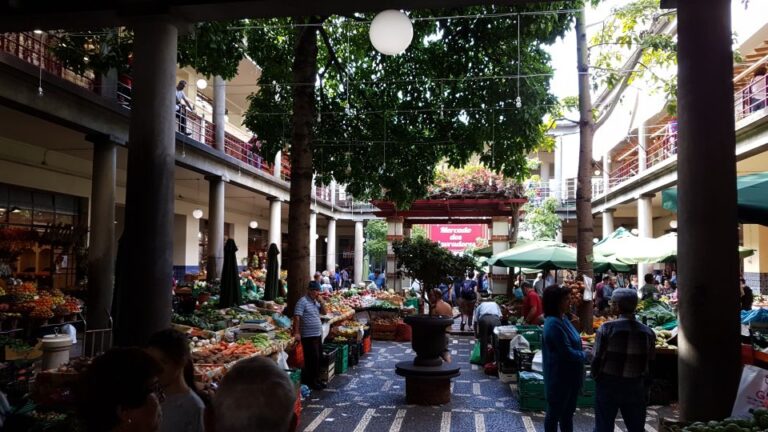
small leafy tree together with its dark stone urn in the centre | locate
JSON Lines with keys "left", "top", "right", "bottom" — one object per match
{"left": 392, "top": 238, "right": 474, "bottom": 366}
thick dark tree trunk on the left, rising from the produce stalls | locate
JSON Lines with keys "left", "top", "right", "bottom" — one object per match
{"left": 286, "top": 22, "right": 318, "bottom": 314}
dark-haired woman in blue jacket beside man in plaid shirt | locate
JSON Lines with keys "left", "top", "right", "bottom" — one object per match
{"left": 542, "top": 285, "right": 586, "bottom": 432}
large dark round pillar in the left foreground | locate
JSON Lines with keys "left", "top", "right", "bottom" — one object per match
{"left": 115, "top": 16, "right": 178, "bottom": 346}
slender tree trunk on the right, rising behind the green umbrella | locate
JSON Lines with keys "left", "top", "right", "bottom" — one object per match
{"left": 576, "top": 8, "right": 595, "bottom": 333}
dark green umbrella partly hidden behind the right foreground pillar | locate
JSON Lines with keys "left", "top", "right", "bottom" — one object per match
{"left": 661, "top": 172, "right": 768, "bottom": 226}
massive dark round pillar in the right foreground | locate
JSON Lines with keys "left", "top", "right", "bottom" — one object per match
{"left": 677, "top": 0, "right": 741, "bottom": 421}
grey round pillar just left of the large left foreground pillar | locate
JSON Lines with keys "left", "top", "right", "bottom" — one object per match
{"left": 88, "top": 137, "right": 117, "bottom": 329}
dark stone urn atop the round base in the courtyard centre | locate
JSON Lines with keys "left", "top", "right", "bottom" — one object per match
{"left": 404, "top": 315, "right": 453, "bottom": 366}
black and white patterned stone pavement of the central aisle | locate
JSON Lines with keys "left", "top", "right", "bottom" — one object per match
{"left": 299, "top": 336, "right": 672, "bottom": 432}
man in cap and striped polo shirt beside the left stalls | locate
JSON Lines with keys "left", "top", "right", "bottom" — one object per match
{"left": 293, "top": 281, "right": 326, "bottom": 390}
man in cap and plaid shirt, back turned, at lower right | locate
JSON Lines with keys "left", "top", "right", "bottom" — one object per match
{"left": 592, "top": 288, "right": 656, "bottom": 432}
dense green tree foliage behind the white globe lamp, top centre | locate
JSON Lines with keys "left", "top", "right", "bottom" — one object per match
{"left": 245, "top": 2, "right": 577, "bottom": 205}
